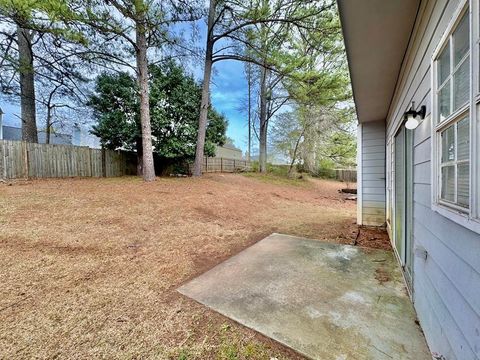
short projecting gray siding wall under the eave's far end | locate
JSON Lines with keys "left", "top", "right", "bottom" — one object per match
{"left": 358, "top": 121, "right": 385, "bottom": 226}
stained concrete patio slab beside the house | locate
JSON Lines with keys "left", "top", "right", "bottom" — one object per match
{"left": 179, "top": 234, "right": 431, "bottom": 360}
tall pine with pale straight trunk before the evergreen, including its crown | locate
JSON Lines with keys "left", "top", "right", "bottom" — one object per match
{"left": 73, "top": 0, "right": 202, "bottom": 181}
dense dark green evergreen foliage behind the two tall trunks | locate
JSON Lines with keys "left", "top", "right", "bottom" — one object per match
{"left": 90, "top": 61, "right": 227, "bottom": 167}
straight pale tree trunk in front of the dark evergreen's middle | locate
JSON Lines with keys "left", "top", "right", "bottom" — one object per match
{"left": 136, "top": 14, "right": 155, "bottom": 181}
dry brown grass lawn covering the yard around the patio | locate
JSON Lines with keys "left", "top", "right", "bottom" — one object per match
{"left": 0, "top": 175, "right": 388, "bottom": 359}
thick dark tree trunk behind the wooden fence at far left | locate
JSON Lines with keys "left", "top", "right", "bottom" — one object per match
{"left": 17, "top": 25, "right": 38, "bottom": 143}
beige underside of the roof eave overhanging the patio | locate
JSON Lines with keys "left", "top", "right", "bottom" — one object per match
{"left": 338, "top": 0, "right": 420, "bottom": 123}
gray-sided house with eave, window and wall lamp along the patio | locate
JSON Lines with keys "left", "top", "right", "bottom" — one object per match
{"left": 338, "top": 0, "right": 480, "bottom": 360}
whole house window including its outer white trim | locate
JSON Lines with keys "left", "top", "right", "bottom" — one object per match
{"left": 431, "top": 0, "right": 480, "bottom": 234}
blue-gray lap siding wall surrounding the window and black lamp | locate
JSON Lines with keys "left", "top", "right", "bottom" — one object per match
{"left": 387, "top": 0, "right": 480, "bottom": 360}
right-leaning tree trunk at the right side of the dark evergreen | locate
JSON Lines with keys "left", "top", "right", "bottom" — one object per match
{"left": 193, "top": 0, "right": 217, "bottom": 176}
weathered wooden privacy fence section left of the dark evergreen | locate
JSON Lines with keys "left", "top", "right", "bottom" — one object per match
{"left": 0, "top": 140, "right": 136, "bottom": 179}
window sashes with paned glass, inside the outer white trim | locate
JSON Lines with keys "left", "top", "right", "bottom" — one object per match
{"left": 435, "top": 9, "right": 471, "bottom": 212}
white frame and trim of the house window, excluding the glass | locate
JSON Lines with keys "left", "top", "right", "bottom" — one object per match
{"left": 431, "top": 0, "right": 480, "bottom": 233}
